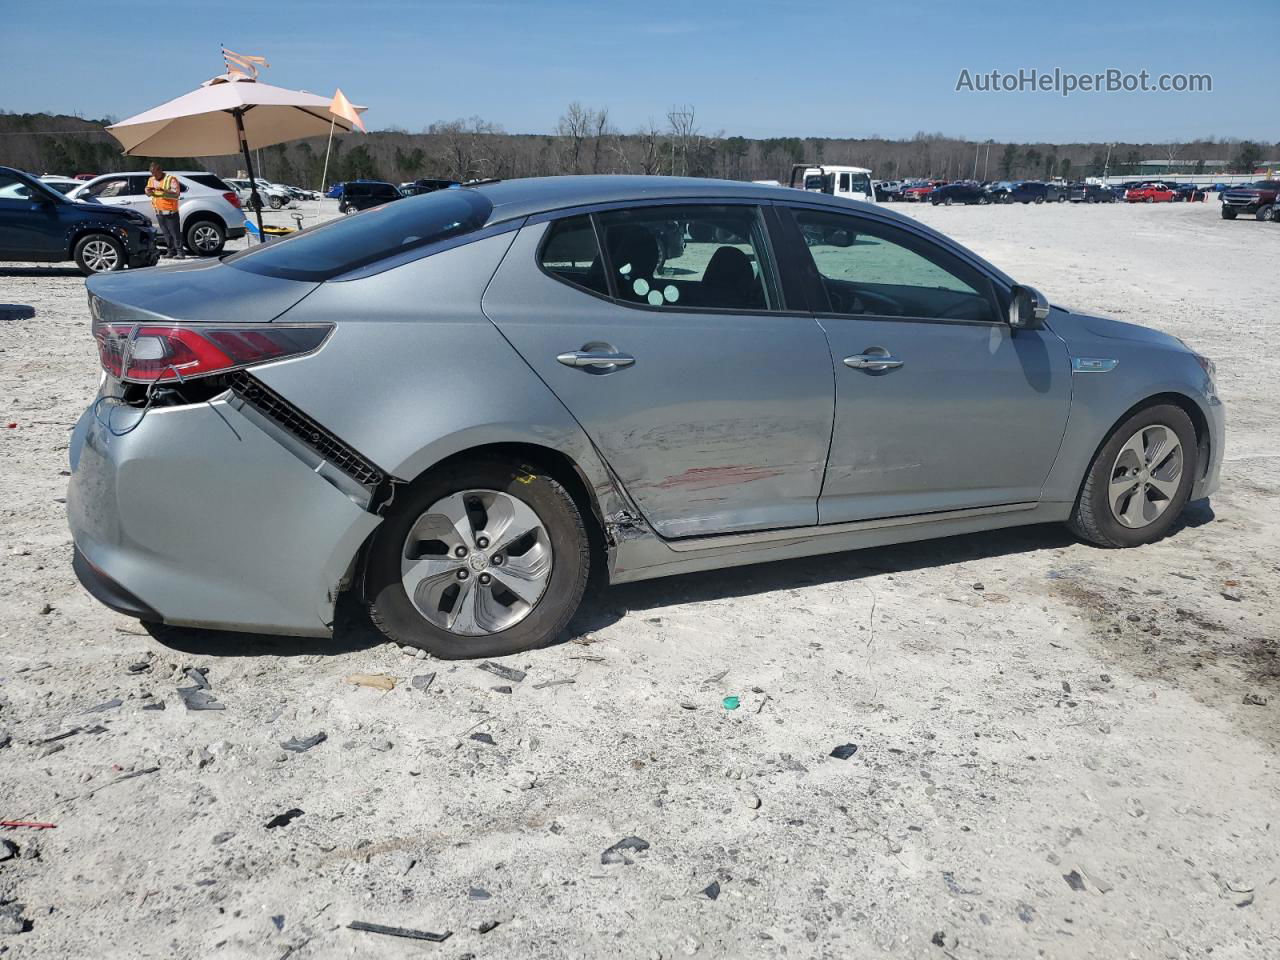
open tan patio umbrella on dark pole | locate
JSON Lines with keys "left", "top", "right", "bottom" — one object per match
{"left": 106, "top": 50, "right": 366, "bottom": 237}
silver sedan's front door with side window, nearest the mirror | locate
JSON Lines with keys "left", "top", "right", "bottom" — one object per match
{"left": 782, "top": 207, "right": 1071, "bottom": 524}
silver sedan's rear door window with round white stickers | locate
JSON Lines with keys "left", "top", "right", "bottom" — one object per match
{"left": 598, "top": 205, "right": 780, "bottom": 310}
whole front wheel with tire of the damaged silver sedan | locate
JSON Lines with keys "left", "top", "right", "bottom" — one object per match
{"left": 1068, "top": 403, "right": 1197, "bottom": 547}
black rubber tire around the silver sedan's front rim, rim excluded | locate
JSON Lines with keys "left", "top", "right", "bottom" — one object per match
{"left": 1066, "top": 403, "right": 1199, "bottom": 547}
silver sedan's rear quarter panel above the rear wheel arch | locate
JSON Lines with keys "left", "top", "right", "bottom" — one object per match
{"left": 253, "top": 232, "right": 628, "bottom": 555}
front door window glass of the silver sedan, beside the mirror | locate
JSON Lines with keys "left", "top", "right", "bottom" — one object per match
{"left": 794, "top": 210, "right": 996, "bottom": 321}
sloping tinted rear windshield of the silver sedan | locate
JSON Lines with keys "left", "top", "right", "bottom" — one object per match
{"left": 223, "top": 189, "right": 493, "bottom": 282}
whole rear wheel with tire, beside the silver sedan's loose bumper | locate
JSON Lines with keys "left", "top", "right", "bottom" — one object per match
{"left": 367, "top": 461, "right": 590, "bottom": 659}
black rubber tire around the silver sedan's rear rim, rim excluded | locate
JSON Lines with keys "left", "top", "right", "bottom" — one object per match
{"left": 365, "top": 460, "right": 591, "bottom": 660}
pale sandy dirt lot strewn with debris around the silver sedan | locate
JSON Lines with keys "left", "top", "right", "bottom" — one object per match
{"left": 0, "top": 202, "right": 1280, "bottom": 960}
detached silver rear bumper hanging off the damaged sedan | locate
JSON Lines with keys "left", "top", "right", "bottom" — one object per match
{"left": 67, "top": 399, "right": 379, "bottom": 635}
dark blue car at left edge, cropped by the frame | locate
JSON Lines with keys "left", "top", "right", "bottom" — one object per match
{"left": 0, "top": 166, "right": 160, "bottom": 275}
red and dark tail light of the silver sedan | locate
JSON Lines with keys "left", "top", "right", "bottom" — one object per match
{"left": 93, "top": 323, "right": 333, "bottom": 384}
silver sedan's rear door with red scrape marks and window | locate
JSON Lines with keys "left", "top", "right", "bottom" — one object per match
{"left": 477, "top": 204, "right": 833, "bottom": 538}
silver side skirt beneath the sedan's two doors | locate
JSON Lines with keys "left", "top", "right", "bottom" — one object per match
{"left": 609, "top": 503, "right": 1071, "bottom": 584}
